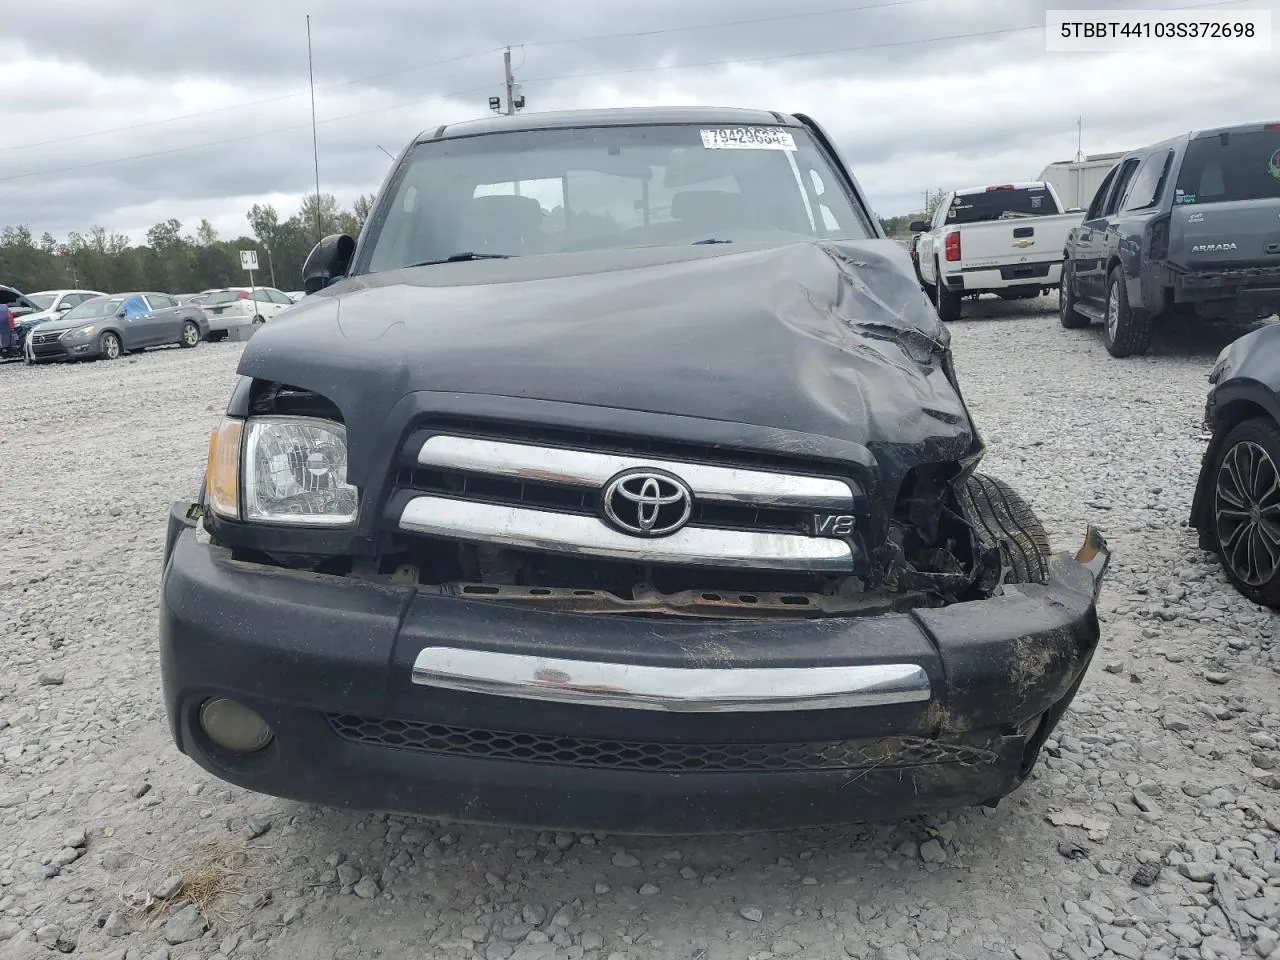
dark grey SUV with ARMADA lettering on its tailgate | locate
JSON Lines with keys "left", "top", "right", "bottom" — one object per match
{"left": 1059, "top": 123, "right": 1280, "bottom": 357}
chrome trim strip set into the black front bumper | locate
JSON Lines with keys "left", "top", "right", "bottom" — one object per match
{"left": 412, "top": 646, "right": 932, "bottom": 713}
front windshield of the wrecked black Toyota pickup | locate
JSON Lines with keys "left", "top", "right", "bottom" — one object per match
{"left": 362, "top": 124, "right": 873, "bottom": 271}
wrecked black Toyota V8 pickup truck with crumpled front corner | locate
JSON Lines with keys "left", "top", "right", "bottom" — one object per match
{"left": 160, "top": 109, "right": 1108, "bottom": 833}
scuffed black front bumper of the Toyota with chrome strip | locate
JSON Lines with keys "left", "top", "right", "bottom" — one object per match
{"left": 160, "top": 504, "right": 1107, "bottom": 833}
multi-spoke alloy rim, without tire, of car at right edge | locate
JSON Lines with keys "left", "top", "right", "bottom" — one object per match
{"left": 1213, "top": 440, "right": 1280, "bottom": 586}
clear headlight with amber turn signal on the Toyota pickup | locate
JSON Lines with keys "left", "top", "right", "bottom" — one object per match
{"left": 206, "top": 417, "right": 358, "bottom": 526}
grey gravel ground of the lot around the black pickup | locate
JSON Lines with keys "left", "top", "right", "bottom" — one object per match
{"left": 0, "top": 301, "right": 1280, "bottom": 960}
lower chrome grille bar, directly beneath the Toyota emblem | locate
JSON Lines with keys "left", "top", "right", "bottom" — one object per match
{"left": 399, "top": 497, "right": 854, "bottom": 573}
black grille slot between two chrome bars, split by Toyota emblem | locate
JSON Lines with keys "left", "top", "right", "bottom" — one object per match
{"left": 396, "top": 467, "right": 814, "bottom": 534}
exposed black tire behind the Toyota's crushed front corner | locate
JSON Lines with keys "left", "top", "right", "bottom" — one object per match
{"left": 960, "top": 474, "right": 1051, "bottom": 584}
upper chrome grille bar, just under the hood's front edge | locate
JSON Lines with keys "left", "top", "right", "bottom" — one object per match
{"left": 417, "top": 434, "right": 854, "bottom": 511}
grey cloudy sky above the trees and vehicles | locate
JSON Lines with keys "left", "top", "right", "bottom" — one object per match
{"left": 0, "top": 0, "right": 1280, "bottom": 244}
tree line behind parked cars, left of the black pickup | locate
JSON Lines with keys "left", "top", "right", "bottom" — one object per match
{"left": 0, "top": 193, "right": 374, "bottom": 293}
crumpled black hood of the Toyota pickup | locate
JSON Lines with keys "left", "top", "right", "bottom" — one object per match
{"left": 239, "top": 241, "right": 973, "bottom": 447}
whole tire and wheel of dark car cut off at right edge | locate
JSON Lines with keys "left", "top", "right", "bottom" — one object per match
{"left": 1210, "top": 417, "right": 1280, "bottom": 609}
